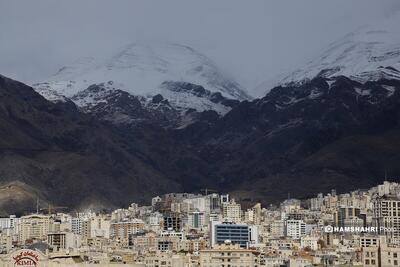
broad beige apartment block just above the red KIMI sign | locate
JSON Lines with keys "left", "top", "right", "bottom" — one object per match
{"left": 18, "top": 214, "right": 51, "bottom": 243}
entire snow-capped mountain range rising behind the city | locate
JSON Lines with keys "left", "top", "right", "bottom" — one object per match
{"left": 0, "top": 18, "right": 400, "bottom": 212}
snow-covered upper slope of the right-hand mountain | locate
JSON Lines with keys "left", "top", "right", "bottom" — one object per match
{"left": 256, "top": 14, "right": 400, "bottom": 96}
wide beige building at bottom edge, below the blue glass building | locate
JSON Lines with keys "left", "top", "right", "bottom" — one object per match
{"left": 200, "top": 242, "right": 258, "bottom": 267}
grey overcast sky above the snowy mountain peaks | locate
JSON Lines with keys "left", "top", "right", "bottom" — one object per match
{"left": 0, "top": 0, "right": 400, "bottom": 96}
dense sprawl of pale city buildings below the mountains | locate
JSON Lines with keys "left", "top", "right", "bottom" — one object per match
{"left": 0, "top": 181, "right": 400, "bottom": 267}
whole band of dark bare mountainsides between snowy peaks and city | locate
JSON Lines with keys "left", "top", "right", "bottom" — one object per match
{"left": 0, "top": 71, "right": 400, "bottom": 216}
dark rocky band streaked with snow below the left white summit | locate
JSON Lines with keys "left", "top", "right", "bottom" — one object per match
{"left": 67, "top": 81, "right": 240, "bottom": 128}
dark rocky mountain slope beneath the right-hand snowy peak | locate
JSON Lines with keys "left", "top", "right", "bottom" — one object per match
{"left": 180, "top": 76, "right": 400, "bottom": 203}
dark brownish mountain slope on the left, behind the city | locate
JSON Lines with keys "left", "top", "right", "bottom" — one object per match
{"left": 0, "top": 76, "right": 201, "bottom": 216}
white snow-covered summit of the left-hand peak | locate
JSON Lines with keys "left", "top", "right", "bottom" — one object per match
{"left": 34, "top": 44, "right": 250, "bottom": 123}
